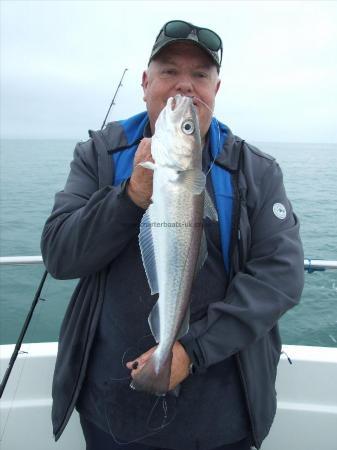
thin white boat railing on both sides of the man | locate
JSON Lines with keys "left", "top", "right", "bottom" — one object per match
{"left": 0, "top": 255, "right": 337, "bottom": 273}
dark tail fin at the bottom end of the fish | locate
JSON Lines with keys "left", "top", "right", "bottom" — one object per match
{"left": 130, "top": 351, "right": 172, "bottom": 396}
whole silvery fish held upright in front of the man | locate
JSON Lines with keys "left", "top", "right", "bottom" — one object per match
{"left": 130, "top": 95, "right": 217, "bottom": 396}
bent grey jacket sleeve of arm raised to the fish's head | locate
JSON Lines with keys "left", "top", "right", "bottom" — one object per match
{"left": 41, "top": 140, "right": 144, "bottom": 279}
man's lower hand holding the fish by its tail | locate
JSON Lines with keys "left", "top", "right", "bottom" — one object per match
{"left": 126, "top": 341, "right": 191, "bottom": 391}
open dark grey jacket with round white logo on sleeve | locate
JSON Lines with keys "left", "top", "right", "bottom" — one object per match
{"left": 41, "top": 123, "right": 304, "bottom": 448}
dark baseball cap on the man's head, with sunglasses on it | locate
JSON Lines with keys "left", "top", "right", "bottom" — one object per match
{"left": 149, "top": 20, "right": 222, "bottom": 70}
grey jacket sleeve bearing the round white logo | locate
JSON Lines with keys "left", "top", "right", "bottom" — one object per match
{"left": 180, "top": 162, "right": 304, "bottom": 370}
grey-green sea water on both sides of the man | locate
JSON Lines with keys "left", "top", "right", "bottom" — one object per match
{"left": 0, "top": 140, "right": 337, "bottom": 347}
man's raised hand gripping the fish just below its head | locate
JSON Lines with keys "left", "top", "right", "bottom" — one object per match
{"left": 127, "top": 138, "right": 154, "bottom": 209}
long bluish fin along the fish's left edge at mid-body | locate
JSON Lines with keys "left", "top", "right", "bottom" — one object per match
{"left": 138, "top": 210, "right": 159, "bottom": 295}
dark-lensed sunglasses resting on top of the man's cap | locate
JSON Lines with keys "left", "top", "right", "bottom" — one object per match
{"left": 157, "top": 20, "right": 222, "bottom": 65}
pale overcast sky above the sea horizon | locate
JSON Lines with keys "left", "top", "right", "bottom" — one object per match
{"left": 0, "top": 0, "right": 337, "bottom": 142}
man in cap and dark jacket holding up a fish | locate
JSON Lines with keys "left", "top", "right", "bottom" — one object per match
{"left": 41, "top": 20, "right": 303, "bottom": 450}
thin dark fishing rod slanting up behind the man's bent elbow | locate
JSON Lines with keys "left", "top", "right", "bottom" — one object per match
{"left": 0, "top": 68, "right": 128, "bottom": 398}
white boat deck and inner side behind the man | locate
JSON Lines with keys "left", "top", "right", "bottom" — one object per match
{"left": 0, "top": 343, "right": 337, "bottom": 450}
